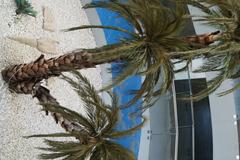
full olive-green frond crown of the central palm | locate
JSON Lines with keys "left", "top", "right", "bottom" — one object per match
{"left": 65, "top": 0, "right": 188, "bottom": 105}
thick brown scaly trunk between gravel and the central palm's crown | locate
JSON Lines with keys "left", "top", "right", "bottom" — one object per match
{"left": 2, "top": 51, "right": 97, "bottom": 83}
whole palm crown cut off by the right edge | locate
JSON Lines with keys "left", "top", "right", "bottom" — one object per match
{"left": 172, "top": 0, "right": 240, "bottom": 100}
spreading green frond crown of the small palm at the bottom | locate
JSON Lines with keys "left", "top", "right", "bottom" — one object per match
{"left": 25, "top": 71, "right": 145, "bottom": 160}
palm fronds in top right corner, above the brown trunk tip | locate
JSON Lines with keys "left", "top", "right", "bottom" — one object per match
{"left": 175, "top": 0, "right": 240, "bottom": 41}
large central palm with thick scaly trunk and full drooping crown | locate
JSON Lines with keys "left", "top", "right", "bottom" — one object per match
{"left": 2, "top": 0, "right": 217, "bottom": 108}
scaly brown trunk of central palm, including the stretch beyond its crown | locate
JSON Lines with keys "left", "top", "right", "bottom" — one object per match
{"left": 2, "top": 31, "right": 219, "bottom": 94}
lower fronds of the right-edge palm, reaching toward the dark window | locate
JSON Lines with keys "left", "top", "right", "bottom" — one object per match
{"left": 182, "top": 53, "right": 239, "bottom": 101}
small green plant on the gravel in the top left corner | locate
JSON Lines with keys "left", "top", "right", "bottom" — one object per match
{"left": 15, "top": 0, "right": 37, "bottom": 17}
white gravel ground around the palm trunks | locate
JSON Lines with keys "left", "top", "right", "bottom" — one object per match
{"left": 0, "top": 0, "right": 102, "bottom": 160}
